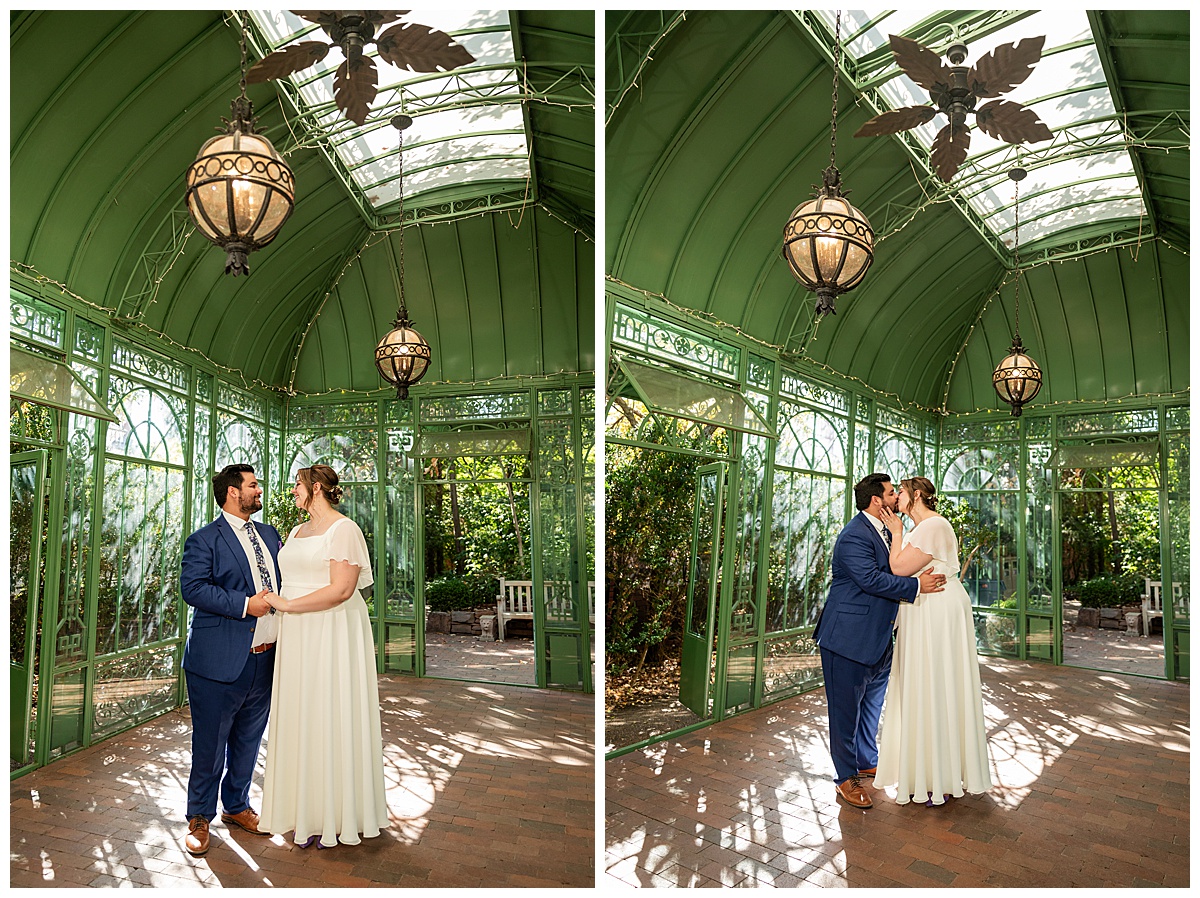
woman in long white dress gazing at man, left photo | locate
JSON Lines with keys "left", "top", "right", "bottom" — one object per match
{"left": 259, "top": 465, "right": 388, "bottom": 848}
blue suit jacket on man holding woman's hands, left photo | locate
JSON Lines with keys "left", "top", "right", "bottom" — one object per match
{"left": 179, "top": 515, "right": 282, "bottom": 683}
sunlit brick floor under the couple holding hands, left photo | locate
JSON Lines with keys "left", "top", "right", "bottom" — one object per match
{"left": 10, "top": 677, "right": 590, "bottom": 888}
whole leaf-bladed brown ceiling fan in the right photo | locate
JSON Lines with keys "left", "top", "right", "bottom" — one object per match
{"left": 854, "top": 35, "right": 1054, "bottom": 182}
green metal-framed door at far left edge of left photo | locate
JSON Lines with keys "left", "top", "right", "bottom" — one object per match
{"left": 8, "top": 449, "right": 47, "bottom": 766}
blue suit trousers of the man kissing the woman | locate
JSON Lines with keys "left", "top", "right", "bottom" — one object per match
{"left": 821, "top": 640, "right": 892, "bottom": 783}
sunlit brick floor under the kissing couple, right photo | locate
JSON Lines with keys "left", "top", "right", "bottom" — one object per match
{"left": 601, "top": 658, "right": 1190, "bottom": 888}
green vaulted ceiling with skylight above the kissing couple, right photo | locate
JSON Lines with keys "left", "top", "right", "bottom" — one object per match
{"left": 605, "top": 10, "right": 1190, "bottom": 413}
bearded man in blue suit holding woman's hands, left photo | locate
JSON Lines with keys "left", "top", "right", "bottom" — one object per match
{"left": 180, "top": 465, "right": 281, "bottom": 857}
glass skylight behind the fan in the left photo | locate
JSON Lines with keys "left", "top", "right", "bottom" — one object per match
{"left": 250, "top": 5, "right": 530, "bottom": 209}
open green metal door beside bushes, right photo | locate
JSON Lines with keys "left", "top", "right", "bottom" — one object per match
{"left": 679, "top": 462, "right": 726, "bottom": 718}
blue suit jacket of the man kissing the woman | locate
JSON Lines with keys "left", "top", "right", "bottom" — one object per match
{"left": 812, "top": 511, "right": 918, "bottom": 665}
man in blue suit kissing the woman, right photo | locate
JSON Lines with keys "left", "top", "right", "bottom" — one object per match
{"left": 812, "top": 474, "right": 946, "bottom": 808}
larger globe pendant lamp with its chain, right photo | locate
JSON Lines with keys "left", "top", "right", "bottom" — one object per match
{"left": 784, "top": 11, "right": 875, "bottom": 318}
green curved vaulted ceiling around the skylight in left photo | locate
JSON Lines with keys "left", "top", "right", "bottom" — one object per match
{"left": 10, "top": 11, "right": 595, "bottom": 394}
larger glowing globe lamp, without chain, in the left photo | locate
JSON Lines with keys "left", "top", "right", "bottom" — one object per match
{"left": 186, "top": 121, "right": 295, "bottom": 277}
